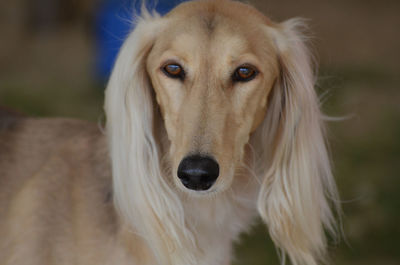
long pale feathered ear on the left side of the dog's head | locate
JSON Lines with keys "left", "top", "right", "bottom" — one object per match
{"left": 105, "top": 10, "right": 197, "bottom": 265}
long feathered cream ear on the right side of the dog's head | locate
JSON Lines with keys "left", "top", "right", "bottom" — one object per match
{"left": 258, "top": 19, "right": 337, "bottom": 265}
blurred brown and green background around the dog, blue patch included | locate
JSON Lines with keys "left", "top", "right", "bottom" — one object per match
{"left": 0, "top": 0, "right": 400, "bottom": 265}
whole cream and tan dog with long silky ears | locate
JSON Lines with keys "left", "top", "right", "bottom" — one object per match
{"left": 0, "top": 0, "right": 340, "bottom": 265}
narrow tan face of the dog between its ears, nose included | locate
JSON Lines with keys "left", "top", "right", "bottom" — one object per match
{"left": 147, "top": 3, "right": 278, "bottom": 192}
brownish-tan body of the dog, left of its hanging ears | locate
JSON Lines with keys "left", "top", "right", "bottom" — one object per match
{"left": 0, "top": 111, "right": 120, "bottom": 264}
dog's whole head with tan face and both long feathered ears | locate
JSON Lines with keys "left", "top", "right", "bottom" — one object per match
{"left": 106, "top": 0, "right": 336, "bottom": 264}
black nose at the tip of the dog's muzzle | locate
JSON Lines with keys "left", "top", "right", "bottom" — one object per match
{"left": 178, "top": 155, "right": 219, "bottom": 190}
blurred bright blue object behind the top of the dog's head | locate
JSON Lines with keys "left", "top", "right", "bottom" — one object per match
{"left": 95, "top": 0, "right": 187, "bottom": 81}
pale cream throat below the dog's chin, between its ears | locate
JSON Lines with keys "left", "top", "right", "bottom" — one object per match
{"left": 184, "top": 176, "right": 258, "bottom": 264}
